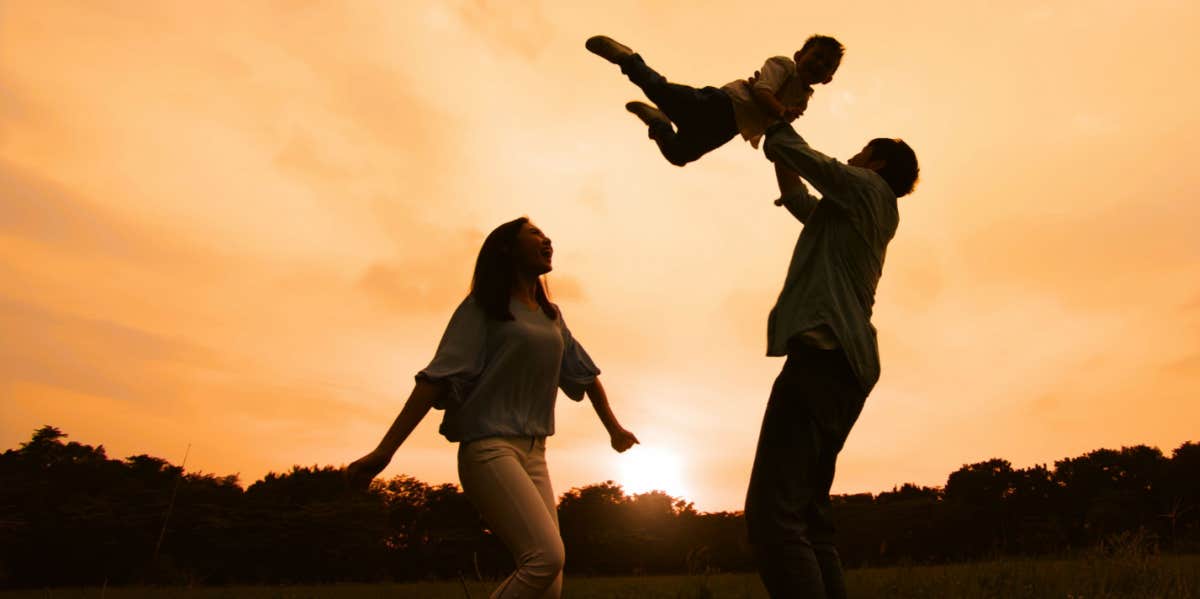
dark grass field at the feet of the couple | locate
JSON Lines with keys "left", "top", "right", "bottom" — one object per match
{"left": 0, "top": 556, "right": 1200, "bottom": 599}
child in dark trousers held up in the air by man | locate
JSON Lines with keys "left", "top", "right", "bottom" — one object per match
{"left": 584, "top": 35, "right": 845, "bottom": 167}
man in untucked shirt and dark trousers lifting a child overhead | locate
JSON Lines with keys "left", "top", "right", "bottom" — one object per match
{"left": 745, "top": 122, "right": 918, "bottom": 599}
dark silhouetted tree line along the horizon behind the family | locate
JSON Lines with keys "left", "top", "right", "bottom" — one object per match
{"left": 0, "top": 426, "right": 1200, "bottom": 588}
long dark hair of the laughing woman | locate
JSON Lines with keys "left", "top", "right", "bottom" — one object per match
{"left": 470, "top": 216, "right": 558, "bottom": 321}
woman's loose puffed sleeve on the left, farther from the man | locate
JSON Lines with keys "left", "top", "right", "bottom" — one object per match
{"left": 416, "top": 296, "right": 487, "bottom": 409}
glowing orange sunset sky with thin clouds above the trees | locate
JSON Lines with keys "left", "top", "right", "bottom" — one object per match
{"left": 0, "top": 0, "right": 1200, "bottom": 511}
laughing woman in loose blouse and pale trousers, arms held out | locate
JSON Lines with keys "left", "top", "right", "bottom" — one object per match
{"left": 347, "top": 217, "right": 637, "bottom": 599}
